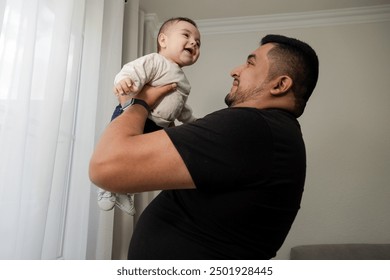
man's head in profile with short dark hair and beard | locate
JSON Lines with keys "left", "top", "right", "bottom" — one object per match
{"left": 225, "top": 35, "right": 318, "bottom": 117}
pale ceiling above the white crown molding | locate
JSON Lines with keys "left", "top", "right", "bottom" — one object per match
{"left": 140, "top": 0, "right": 390, "bottom": 21}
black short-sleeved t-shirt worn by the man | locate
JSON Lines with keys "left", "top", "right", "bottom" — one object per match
{"left": 128, "top": 108, "right": 306, "bottom": 259}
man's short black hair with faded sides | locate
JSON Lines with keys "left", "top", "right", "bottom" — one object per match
{"left": 260, "top": 34, "right": 319, "bottom": 116}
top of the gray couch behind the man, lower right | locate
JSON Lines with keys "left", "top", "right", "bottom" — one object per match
{"left": 290, "top": 244, "right": 390, "bottom": 260}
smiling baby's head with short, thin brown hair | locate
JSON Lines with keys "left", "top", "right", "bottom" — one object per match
{"left": 157, "top": 17, "right": 200, "bottom": 67}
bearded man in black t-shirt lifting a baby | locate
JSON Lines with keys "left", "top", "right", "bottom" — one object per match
{"left": 90, "top": 35, "right": 318, "bottom": 259}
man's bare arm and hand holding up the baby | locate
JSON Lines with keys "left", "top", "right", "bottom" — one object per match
{"left": 89, "top": 85, "right": 195, "bottom": 193}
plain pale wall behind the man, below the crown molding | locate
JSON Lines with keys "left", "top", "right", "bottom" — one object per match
{"left": 184, "top": 7, "right": 390, "bottom": 259}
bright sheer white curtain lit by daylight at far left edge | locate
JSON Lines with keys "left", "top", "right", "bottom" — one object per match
{"left": 0, "top": 0, "right": 84, "bottom": 259}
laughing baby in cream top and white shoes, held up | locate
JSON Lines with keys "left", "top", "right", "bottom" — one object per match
{"left": 98, "top": 17, "right": 200, "bottom": 215}
